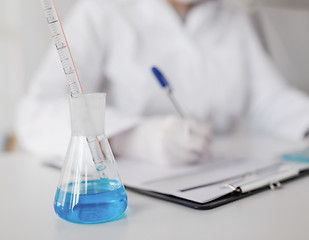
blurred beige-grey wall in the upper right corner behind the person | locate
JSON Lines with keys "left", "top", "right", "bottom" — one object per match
{"left": 251, "top": 0, "right": 309, "bottom": 93}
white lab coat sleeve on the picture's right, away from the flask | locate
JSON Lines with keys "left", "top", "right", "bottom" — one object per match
{"left": 242, "top": 16, "right": 309, "bottom": 140}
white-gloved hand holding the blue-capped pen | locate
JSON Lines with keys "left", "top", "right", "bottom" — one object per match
{"left": 111, "top": 116, "right": 212, "bottom": 164}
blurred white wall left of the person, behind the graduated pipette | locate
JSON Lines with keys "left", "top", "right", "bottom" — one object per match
{"left": 0, "top": 0, "right": 77, "bottom": 141}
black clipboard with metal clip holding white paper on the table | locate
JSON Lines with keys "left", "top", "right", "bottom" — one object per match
{"left": 118, "top": 159, "right": 309, "bottom": 210}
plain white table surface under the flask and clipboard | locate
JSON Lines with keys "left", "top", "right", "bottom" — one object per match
{"left": 0, "top": 133, "right": 309, "bottom": 240}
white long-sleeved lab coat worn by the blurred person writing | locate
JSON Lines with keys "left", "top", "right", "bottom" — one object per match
{"left": 17, "top": 0, "right": 309, "bottom": 157}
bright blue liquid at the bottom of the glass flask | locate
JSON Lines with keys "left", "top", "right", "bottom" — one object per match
{"left": 54, "top": 179, "right": 127, "bottom": 224}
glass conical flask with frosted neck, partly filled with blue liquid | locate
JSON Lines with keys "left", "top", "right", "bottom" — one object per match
{"left": 54, "top": 93, "right": 127, "bottom": 223}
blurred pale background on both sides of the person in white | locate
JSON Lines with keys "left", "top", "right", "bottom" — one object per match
{"left": 0, "top": 0, "right": 309, "bottom": 151}
